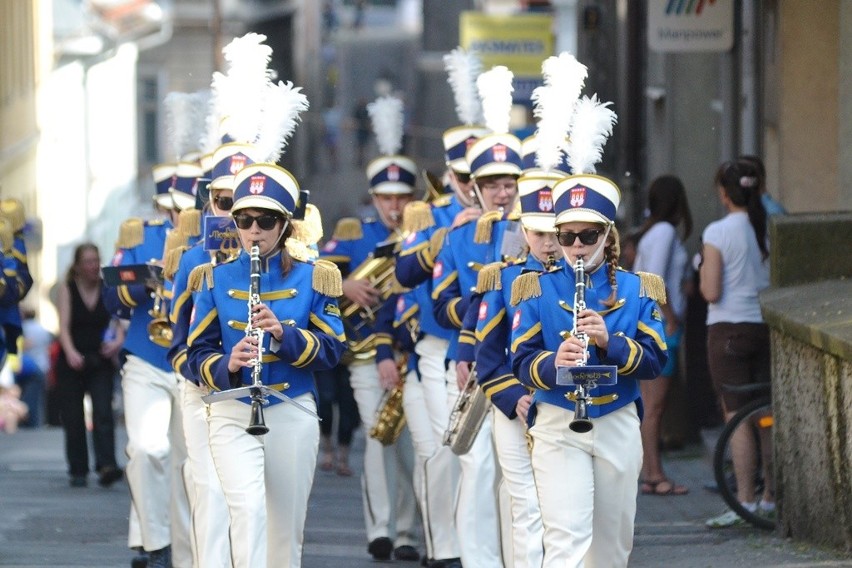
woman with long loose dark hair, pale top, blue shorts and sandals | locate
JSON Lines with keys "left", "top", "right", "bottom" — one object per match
{"left": 633, "top": 175, "right": 692, "bottom": 495}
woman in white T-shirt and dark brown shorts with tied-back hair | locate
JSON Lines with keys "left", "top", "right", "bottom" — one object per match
{"left": 699, "top": 160, "right": 775, "bottom": 528}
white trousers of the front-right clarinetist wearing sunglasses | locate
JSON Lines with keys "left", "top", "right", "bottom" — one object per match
{"left": 530, "top": 404, "right": 642, "bottom": 568}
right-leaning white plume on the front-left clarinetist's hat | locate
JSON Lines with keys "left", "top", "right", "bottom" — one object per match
{"left": 255, "top": 81, "right": 308, "bottom": 164}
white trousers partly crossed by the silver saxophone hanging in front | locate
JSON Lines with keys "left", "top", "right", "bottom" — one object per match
{"left": 447, "top": 361, "right": 503, "bottom": 568}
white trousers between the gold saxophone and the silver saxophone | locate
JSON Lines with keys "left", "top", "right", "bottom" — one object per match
{"left": 403, "top": 364, "right": 459, "bottom": 559}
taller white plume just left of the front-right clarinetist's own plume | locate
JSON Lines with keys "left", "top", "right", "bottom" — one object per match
{"left": 532, "top": 52, "right": 589, "bottom": 171}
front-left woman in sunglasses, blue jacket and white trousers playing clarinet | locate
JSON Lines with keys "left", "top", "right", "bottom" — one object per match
{"left": 187, "top": 164, "right": 344, "bottom": 568}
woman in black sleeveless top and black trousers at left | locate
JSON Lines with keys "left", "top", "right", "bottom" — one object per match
{"left": 56, "top": 243, "right": 124, "bottom": 487}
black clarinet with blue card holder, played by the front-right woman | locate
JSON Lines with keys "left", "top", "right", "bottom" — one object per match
{"left": 556, "top": 258, "right": 617, "bottom": 434}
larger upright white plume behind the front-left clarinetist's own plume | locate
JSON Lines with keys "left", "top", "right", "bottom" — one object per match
{"left": 213, "top": 33, "right": 272, "bottom": 142}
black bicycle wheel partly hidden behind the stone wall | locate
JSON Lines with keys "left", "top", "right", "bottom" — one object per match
{"left": 713, "top": 398, "right": 775, "bottom": 530}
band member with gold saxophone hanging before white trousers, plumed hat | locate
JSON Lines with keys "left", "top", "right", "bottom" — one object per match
{"left": 320, "top": 97, "right": 420, "bottom": 561}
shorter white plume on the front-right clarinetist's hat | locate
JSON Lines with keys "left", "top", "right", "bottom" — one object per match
{"left": 568, "top": 95, "right": 618, "bottom": 174}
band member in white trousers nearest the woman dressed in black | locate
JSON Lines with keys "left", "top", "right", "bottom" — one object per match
{"left": 104, "top": 164, "right": 192, "bottom": 568}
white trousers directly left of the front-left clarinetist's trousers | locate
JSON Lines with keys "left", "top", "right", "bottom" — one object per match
{"left": 181, "top": 380, "right": 231, "bottom": 568}
